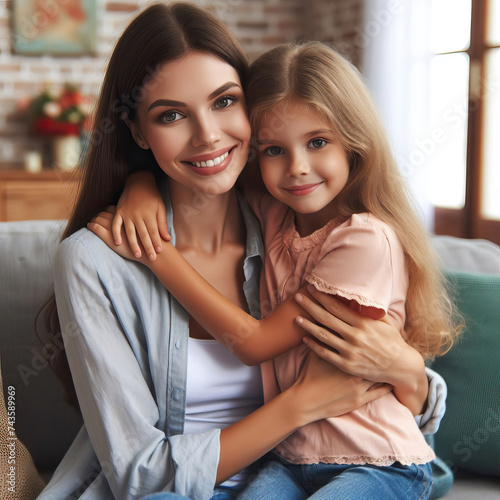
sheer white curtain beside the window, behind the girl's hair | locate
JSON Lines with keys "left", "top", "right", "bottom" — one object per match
{"left": 357, "top": 0, "right": 434, "bottom": 229}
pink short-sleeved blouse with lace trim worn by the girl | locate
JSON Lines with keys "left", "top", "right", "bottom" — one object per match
{"left": 252, "top": 196, "right": 435, "bottom": 466}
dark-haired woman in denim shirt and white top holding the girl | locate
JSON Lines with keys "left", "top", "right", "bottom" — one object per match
{"left": 39, "top": 4, "right": 446, "bottom": 500}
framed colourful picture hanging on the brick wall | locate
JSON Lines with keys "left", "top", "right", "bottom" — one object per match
{"left": 12, "top": 0, "right": 96, "bottom": 56}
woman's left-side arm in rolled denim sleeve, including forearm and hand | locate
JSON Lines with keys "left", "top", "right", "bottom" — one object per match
{"left": 52, "top": 232, "right": 389, "bottom": 500}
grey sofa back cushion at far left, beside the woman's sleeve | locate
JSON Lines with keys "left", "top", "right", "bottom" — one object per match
{"left": 0, "top": 221, "right": 81, "bottom": 473}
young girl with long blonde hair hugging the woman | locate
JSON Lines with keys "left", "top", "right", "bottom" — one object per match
{"left": 90, "top": 42, "right": 457, "bottom": 499}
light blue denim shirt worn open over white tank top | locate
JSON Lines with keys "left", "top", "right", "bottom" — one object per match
{"left": 38, "top": 181, "right": 446, "bottom": 500}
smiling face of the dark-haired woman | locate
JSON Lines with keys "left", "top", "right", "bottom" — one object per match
{"left": 131, "top": 52, "right": 251, "bottom": 195}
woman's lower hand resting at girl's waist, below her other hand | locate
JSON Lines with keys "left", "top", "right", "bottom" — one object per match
{"left": 291, "top": 352, "right": 392, "bottom": 425}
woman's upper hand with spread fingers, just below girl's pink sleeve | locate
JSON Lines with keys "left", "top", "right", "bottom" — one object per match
{"left": 296, "top": 286, "right": 428, "bottom": 415}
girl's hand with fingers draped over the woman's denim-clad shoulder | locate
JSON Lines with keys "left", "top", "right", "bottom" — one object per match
{"left": 111, "top": 171, "right": 170, "bottom": 261}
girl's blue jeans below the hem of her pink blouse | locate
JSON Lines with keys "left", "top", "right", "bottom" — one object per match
{"left": 238, "top": 456, "right": 432, "bottom": 500}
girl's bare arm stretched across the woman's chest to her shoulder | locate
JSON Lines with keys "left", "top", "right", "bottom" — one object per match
{"left": 88, "top": 207, "right": 314, "bottom": 365}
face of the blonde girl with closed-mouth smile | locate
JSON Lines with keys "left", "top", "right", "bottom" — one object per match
{"left": 257, "top": 103, "right": 349, "bottom": 221}
